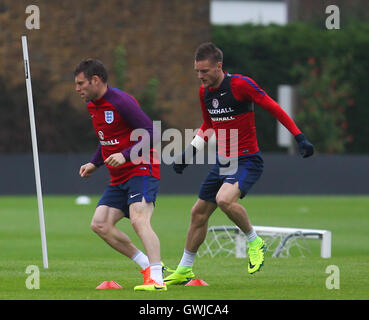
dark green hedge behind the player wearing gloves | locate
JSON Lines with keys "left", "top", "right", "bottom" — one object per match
{"left": 212, "top": 23, "right": 369, "bottom": 153}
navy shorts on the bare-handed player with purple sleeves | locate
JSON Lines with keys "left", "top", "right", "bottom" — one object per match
{"left": 97, "top": 176, "right": 160, "bottom": 218}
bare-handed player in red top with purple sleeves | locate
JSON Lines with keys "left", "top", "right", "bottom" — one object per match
{"left": 74, "top": 59, "right": 167, "bottom": 291}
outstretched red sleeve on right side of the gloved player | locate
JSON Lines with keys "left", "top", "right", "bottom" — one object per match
{"left": 231, "top": 75, "right": 301, "bottom": 136}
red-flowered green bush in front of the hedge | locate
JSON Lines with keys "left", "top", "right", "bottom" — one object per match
{"left": 295, "top": 56, "right": 354, "bottom": 153}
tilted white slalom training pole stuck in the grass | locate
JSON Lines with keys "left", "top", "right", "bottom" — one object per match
{"left": 22, "top": 36, "right": 49, "bottom": 269}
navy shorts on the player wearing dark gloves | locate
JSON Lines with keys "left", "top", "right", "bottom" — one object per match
{"left": 199, "top": 152, "right": 264, "bottom": 203}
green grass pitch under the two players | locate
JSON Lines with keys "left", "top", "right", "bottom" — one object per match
{"left": 0, "top": 195, "right": 369, "bottom": 300}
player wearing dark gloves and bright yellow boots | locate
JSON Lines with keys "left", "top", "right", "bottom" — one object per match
{"left": 164, "top": 43, "right": 314, "bottom": 285}
